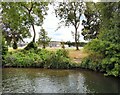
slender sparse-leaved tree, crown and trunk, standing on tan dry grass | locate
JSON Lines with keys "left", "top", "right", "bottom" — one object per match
{"left": 55, "top": 2, "right": 85, "bottom": 50}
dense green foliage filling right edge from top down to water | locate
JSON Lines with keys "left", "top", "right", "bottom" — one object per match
{"left": 81, "top": 2, "right": 120, "bottom": 77}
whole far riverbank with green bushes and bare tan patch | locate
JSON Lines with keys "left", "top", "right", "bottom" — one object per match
{"left": 2, "top": 48, "right": 119, "bottom": 75}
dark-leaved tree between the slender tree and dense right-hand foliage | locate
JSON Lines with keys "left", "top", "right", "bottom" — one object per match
{"left": 82, "top": 2, "right": 101, "bottom": 40}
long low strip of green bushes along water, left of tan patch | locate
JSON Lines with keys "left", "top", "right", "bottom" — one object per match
{"left": 3, "top": 49, "right": 72, "bottom": 69}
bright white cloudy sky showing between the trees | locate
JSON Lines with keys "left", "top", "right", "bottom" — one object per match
{"left": 25, "top": 5, "right": 85, "bottom": 42}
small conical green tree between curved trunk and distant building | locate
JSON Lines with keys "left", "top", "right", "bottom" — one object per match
{"left": 38, "top": 27, "right": 50, "bottom": 49}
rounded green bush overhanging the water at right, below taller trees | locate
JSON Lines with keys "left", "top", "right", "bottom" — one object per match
{"left": 81, "top": 39, "right": 120, "bottom": 77}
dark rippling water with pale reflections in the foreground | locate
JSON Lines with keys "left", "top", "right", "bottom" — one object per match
{"left": 2, "top": 68, "right": 120, "bottom": 93}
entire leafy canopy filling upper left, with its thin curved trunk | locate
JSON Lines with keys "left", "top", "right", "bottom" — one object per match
{"left": 2, "top": 2, "right": 48, "bottom": 49}
